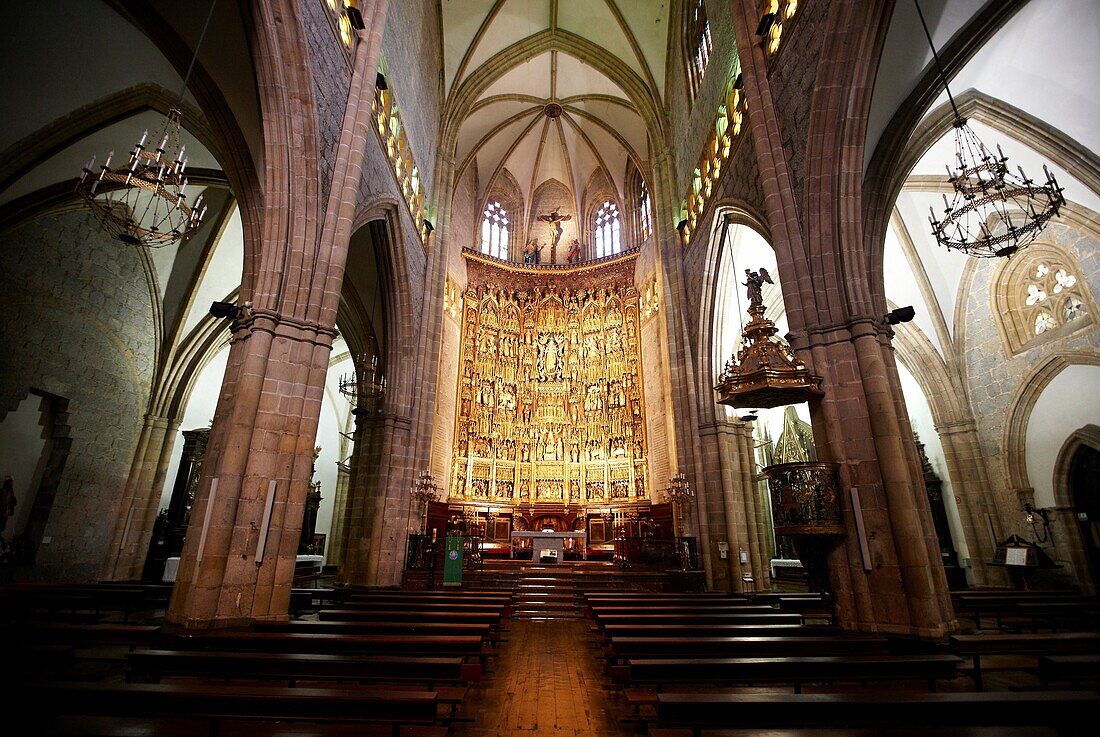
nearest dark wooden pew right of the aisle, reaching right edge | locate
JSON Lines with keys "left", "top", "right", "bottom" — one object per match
{"left": 657, "top": 690, "right": 1100, "bottom": 737}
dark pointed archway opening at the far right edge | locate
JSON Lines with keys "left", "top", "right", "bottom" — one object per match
{"left": 1054, "top": 425, "right": 1100, "bottom": 594}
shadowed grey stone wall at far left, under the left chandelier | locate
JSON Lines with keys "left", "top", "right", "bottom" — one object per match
{"left": 0, "top": 209, "right": 156, "bottom": 581}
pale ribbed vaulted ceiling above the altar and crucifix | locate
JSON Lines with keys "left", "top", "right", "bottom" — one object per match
{"left": 442, "top": 0, "right": 670, "bottom": 220}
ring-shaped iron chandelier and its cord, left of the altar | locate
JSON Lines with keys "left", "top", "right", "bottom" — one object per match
{"left": 76, "top": 0, "right": 217, "bottom": 249}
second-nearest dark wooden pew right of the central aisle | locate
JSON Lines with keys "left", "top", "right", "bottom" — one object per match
{"left": 627, "top": 655, "right": 963, "bottom": 693}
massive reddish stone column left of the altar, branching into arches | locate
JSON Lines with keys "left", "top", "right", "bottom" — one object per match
{"left": 165, "top": 0, "right": 386, "bottom": 629}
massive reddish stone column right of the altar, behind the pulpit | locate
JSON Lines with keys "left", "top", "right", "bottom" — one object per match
{"left": 730, "top": 0, "right": 954, "bottom": 637}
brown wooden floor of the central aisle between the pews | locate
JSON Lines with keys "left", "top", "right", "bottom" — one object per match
{"left": 453, "top": 619, "right": 633, "bottom": 737}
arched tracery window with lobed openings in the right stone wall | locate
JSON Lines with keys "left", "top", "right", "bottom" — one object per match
{"left": 992, "top": 243, "right": 1096, "bottom": 354}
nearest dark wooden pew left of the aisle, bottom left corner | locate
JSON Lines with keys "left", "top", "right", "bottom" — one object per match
{"left": 15, "top": 681, "right": 446, "bottom": 737}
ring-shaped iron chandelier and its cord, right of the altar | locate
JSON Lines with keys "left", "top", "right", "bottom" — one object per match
{"left": 913, "top": 0, "right": 1066, "bottom": 257}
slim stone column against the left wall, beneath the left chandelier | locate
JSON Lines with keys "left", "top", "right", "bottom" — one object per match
{"left": 101, "top": 415, "right": 179, "bottom": 581}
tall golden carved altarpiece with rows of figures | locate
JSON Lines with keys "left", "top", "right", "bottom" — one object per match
{"left": 449, "top": 251, "right": 650, "bottom": 525}
